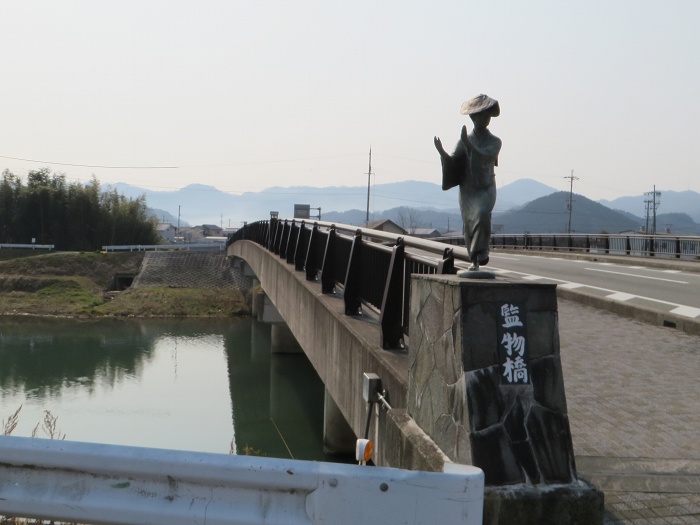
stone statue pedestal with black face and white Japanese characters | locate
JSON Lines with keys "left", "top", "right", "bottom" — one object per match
{"left": 407, "top": 275, "right": 603, "bottom": 524}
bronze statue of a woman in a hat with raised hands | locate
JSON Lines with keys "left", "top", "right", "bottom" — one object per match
{"left": 434, "top": 95, "right": 501, "bottom": 272}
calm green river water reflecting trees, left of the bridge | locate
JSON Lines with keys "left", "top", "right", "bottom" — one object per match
{"left": 0, "top": 317, "right": 326, "bottom": 460}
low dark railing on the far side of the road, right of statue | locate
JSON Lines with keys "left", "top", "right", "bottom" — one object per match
{"left": 486, "top": 233, "right": 700, "bottom": 260}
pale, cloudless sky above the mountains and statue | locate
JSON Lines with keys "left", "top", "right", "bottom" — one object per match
{"left": 0, "top": 0, "right": 700, "bottom": 201}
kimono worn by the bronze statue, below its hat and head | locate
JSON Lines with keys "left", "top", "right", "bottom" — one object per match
{"left": 442, "top": 129, "right": 501, "bottom": 265}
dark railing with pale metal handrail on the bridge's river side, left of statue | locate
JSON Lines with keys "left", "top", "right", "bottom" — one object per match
{"left": 228, "top": 219, "right": 468, "bottom": 348}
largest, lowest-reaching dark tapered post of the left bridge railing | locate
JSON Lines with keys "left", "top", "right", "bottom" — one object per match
{"left": 379, "top": 237, "right": 405, "bottom": 348}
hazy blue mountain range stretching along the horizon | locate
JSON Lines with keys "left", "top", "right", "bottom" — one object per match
{"left": 109, "top": 179, "right": 700, "bottom": 235}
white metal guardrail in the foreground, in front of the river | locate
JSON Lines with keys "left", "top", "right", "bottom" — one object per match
{"left": 0, "top": 436, "right": 484, "bottom": 525}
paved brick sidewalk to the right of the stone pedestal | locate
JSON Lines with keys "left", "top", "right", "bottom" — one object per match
{"left": 559, "top": 299, "right": 700, "bottom": 525}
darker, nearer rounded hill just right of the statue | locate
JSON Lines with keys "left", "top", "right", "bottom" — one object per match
{"left": 493, "top": 191, "right": 641, "bottom": 233}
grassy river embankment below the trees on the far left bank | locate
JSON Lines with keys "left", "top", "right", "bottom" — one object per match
{"left": 0, "top": 249, "right": 248, "bottom": 317}
